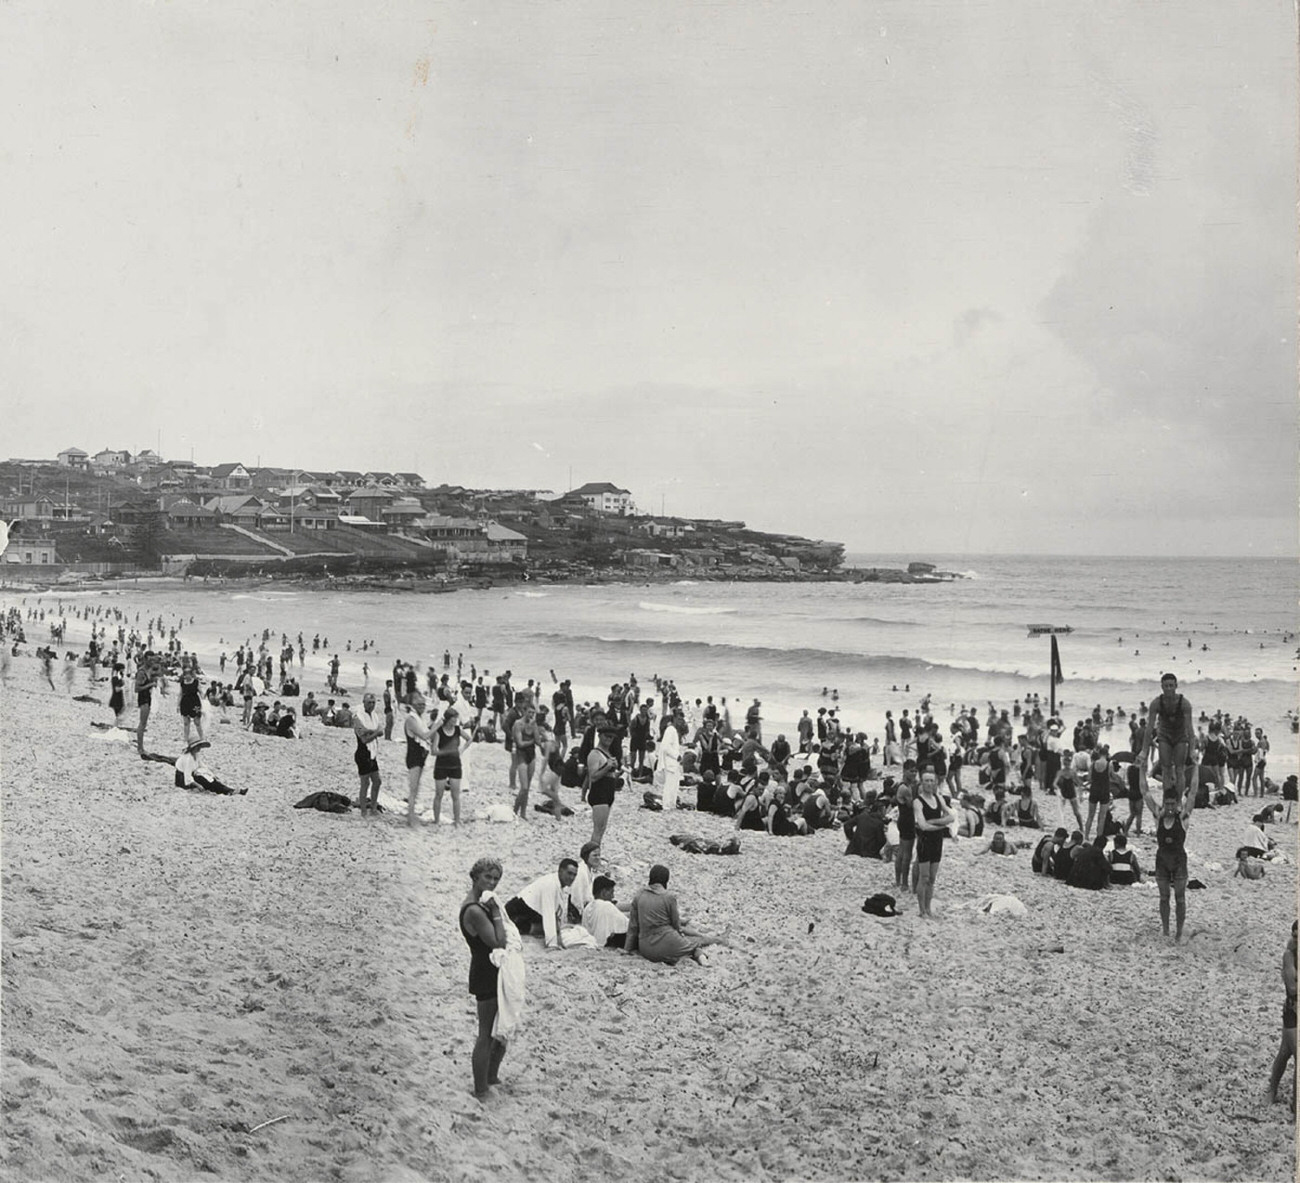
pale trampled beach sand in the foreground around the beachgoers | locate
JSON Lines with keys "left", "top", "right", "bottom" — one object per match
{"left": 0, "top": 658, "right": 1296, "bottom": 1180}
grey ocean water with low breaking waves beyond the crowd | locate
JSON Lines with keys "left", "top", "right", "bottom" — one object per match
{"left": 0, "top": 556, "right": 1300, "bottom": 770}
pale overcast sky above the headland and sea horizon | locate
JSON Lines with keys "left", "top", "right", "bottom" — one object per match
{"left": 0, "top": 0, "right": 1297, "bottom": 555}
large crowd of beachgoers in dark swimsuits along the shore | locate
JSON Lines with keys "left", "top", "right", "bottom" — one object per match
{"left": 0, "top": 595, "right": 1296, "bottom": 1118}
